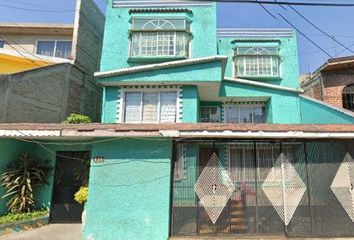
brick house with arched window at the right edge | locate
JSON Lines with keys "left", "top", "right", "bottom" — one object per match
{"left": 302, "top": 56, "right": 354, "bottom": 111}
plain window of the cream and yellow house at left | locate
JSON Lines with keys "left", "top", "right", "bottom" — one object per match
{"left": 37, "top": 40, "right": 72, "bottom": 58}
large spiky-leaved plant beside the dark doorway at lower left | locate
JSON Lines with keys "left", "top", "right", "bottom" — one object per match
{"left": 0, "top": 154, "right": 53, "bottom": 213}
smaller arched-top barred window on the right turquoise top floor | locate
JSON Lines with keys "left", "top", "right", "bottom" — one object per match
{"left": 235, "top": 47, "right": 280, "bottom": 77}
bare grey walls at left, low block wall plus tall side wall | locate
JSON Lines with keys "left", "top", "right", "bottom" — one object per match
{"left": 0, "top": 0, "right": 104, "bottom": 123}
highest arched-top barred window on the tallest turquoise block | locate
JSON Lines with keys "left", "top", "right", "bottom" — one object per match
{"left": 130, "top": 19, "right": 190, "bottom": 57}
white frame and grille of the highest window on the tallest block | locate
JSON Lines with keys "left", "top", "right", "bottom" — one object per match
{"left": 128, "top": 17, "right": 193, "bottom": 58}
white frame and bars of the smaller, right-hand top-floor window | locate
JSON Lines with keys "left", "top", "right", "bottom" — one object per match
{"left": 232, "top": 46, "right": 281, "bottom": 78}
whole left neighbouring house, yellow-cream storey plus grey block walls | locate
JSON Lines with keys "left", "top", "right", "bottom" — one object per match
{"left": 0, "top": 0, "right": 104, "bottom": 123}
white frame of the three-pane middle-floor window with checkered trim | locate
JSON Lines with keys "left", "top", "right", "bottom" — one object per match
{"left": 120, "top": 88, "right": 180, "bottom": 124}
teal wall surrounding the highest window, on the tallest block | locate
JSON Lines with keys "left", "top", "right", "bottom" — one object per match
{"left": 101, "top": 0, "right": 217, "bottom": 71}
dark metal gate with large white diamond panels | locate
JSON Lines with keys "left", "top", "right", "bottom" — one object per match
{"left": 171, "top": 141, "right": 354, "bottom": 237}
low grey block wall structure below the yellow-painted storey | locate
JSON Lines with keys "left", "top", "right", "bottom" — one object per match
{"left": 0, "top": 64, "right": 100, "bottom": 123}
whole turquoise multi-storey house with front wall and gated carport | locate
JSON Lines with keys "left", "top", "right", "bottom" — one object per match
{"left": 0, "top": 0, "right": 354, "bottom": 240}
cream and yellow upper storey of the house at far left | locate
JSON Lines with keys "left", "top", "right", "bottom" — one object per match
{"left": 0, "top": 23, "right": 74, "bottom": 74}
